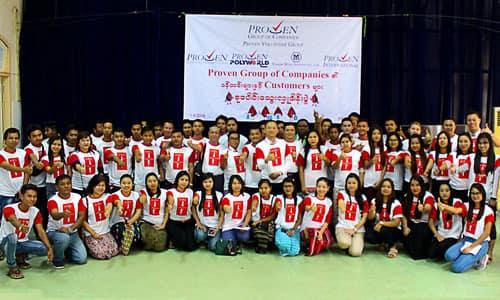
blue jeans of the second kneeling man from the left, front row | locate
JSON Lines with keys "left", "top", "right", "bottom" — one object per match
{"left": 47, "top": 231, "right": 87, "bottom": 264}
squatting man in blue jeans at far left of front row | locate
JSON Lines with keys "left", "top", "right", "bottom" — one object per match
{"left": 0, "top": 184, "right": 54, "bottom": 279}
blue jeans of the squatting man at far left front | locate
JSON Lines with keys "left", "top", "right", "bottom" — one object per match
{"left": 0, "top": 233, "right": 47, "bottom": 268}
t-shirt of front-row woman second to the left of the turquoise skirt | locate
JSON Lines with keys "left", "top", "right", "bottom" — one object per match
{"left": 221, "top": 193, "right": 252, "bottom": 231}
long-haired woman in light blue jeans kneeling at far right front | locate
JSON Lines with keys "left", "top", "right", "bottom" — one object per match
{"left": 444, "top": 183, "right": 495, "bottom": 273}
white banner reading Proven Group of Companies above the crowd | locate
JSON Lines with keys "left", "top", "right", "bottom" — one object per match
{"left": 184, "top": 15, "right": 362, "bottom": 122}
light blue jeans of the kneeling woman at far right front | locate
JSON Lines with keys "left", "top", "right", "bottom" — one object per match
{"left": 444, "top": 237, "right": 488, "bottom": 273}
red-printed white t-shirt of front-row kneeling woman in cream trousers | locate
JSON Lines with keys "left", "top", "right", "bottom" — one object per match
{"left": 337, "top": 191, "right": 370, "bottom": 232}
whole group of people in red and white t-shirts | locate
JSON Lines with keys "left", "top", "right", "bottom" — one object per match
{"left": 0, "top": 112, "right": 500, "bottom": 279}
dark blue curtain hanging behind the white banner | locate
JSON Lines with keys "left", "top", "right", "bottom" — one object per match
{"left": 20, "top": 0, "right": 500, "bottom": 128}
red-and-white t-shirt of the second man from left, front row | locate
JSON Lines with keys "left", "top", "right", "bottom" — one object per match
{"left": 47, "top": 193, "right": 86, "bottom": 232}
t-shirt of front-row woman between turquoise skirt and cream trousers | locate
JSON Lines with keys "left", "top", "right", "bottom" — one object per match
{"left": 301, "top": 195, "right": 332, "bottom": 230}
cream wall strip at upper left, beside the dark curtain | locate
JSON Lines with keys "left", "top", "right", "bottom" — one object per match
{"left": 0, "top": 0, "right": 22, "bottom": 139}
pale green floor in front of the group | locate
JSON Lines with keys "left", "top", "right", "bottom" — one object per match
{"left": 0, "top": 241, "right": 500, "bottom": 300}
